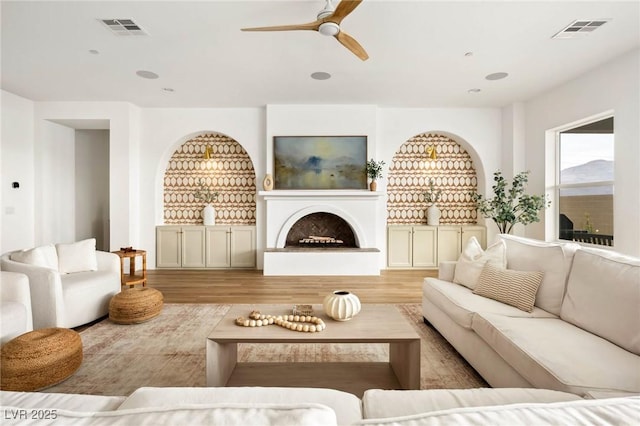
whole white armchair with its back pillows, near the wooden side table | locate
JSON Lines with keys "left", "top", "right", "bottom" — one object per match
{"left": 0, "top": 238, "right": 121, "bottom": 329}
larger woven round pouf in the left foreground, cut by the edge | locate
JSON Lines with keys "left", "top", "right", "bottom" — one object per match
{"left": 0, "top": 328, "right": 82, "bottom": 391}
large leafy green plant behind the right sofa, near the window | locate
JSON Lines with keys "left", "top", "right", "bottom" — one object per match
{"left": 473, "top": 170, "right": 551, "bottom": 234}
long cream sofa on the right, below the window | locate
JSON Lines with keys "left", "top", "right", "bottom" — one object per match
{"left": 422, "top": 235, "right": 640, "bottom": 396}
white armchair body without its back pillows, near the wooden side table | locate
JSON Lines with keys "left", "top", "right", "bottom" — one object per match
{"left": 0, "top": 243, "right": 121, "bottom": 329}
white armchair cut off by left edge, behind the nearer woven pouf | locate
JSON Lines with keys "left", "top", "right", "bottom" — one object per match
{"left": 0, "top": 271, "right": 33, "bottom": 343}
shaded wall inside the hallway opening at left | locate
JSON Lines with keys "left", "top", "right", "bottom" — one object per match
{"left": 75, "top": 130, "right": 109, "bottom": 250}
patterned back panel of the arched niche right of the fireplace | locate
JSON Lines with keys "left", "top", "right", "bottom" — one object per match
{"left": 387, "top": 133, "right": 478, "bottom": 225}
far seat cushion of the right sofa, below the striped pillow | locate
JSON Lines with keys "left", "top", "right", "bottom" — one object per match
{"left": 422, "top": 278, "right": 556, "bottom": 330}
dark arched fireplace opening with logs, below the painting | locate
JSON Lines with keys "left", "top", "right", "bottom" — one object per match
{"left": 285, "top": 212, "right": 358, "bottom": 248}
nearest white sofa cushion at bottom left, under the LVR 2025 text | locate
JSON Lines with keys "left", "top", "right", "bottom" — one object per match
{"left": 0, "top": 403, "right": 337, "bottom": 426}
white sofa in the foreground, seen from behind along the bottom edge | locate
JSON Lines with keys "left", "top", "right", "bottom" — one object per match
{"left": 0, "top": 387, "right": 640, "bottom": 426}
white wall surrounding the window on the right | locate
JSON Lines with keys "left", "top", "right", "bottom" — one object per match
{"left": 525, "top": 50, "right": 640, "bottom": 256}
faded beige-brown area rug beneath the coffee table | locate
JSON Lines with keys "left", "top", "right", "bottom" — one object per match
{"left": 46, "top": 304, "right": 488, "bottom": 396}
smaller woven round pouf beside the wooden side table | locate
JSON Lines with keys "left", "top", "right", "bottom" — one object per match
{"left": 109, "top": 287, "right": 163, "bottom": 324}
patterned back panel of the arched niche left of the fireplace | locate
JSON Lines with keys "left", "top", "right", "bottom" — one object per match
{"left": 163, "top": 133, "right": 256, "bottom": 225}
